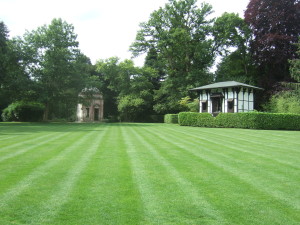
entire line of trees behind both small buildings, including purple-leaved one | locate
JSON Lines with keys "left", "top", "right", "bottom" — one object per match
{"left": 0, "top": 0, "right": 300, "bottom": 121}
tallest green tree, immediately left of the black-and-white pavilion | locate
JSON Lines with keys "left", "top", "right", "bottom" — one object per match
{"left": 130, "top": 0, "right": 215, "bottom": 113}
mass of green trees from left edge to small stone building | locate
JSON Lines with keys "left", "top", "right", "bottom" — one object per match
{"left": 0, "top": 19, "right": 96, "bottom": 120}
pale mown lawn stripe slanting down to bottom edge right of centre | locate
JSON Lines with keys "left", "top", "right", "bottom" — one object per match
{"left": 132, "top": 125, "right": 227, "bottom": 224}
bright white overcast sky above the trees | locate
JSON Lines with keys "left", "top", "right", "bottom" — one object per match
{"left": 0, "top": 0, "right": 250, "bottom": 66}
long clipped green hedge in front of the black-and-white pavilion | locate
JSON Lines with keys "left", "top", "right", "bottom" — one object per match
{"left": 179, "top": 112, "right": 300, "bottom": 130}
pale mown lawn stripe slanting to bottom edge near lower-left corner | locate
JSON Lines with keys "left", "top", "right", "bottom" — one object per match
{"left": 27, "top": 126, "right": 108, "bottom": 224}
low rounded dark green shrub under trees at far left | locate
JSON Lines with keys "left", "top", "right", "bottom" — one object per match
{"left": 2, "top": 101, "right": 44, "bottom": 122}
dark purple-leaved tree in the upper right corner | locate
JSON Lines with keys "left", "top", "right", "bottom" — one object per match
{"left": 245, "top": 0, "right": 300, "bottom": 87}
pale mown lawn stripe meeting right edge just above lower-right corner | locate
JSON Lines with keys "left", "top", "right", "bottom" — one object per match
{"left": 144, "top": 126, "right": 300, "bottom": 214}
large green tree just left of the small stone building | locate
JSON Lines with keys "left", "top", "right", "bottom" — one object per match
{"left": 20, "top": 19, "right": 91, "bottom": 120}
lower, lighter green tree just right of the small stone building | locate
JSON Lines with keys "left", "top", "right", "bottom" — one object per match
{"left": 96, "top": 57, "right": 157, "bottom": 121}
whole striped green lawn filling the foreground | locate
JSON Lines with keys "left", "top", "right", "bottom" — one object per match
{"left": 0, "top": 123, "right": 300, "bottom": 225}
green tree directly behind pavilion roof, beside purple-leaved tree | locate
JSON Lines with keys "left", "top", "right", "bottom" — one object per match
{"left": 213, "top": 13, "right": 257, "bottom": 85}
